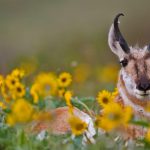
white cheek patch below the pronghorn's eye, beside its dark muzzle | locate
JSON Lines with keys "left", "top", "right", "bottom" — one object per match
{"left": 121, "top": 69, "right": 136, "bottom": 96}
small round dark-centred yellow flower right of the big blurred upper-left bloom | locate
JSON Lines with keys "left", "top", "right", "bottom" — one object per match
{"left": 58, "top": 72, "right": 72, "bottom": 87}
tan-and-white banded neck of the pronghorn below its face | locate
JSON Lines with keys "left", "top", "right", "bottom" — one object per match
{"left": 117, "top": 72, "right": 150, "bottom": 119}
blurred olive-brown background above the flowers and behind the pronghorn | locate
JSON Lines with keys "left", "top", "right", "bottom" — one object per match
{"left": 0, "top": 0, "right": 150, "bottom": 96}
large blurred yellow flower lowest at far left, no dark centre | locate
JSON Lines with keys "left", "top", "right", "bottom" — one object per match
{"left": 7, "top": 99, "right": 34, "bottom": 125}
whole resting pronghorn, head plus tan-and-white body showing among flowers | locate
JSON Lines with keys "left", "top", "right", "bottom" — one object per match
{"left": 32, "top": 13, "right": 150, "bottom": 137}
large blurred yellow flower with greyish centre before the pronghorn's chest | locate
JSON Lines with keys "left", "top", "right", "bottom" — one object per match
{"left": 96, "top": 103, "right": 132, "bottom": 131}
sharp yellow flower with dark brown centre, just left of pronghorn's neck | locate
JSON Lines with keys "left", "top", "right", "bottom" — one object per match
{"left": 97, "top": 90, "right": 113, "bottom": 107}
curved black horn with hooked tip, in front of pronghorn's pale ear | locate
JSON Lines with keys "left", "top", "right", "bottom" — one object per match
{"left": 114, "top": 13, "right": 130, "bottom": 53}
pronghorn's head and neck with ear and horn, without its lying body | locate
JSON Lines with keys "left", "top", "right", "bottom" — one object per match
{"left": 108, "top": 13, "right": 150, "bottom": 119}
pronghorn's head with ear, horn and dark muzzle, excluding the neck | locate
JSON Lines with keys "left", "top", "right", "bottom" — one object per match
{"left": 108, "top": 13, "right": 150, "bottom": 100}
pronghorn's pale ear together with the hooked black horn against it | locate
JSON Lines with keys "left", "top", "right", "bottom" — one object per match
{"left": 108, "top": 13, "right": 130, "bottom": 57}
